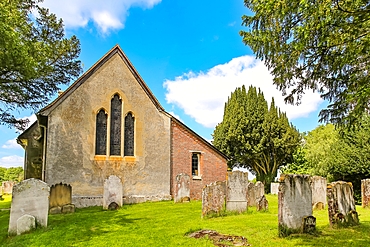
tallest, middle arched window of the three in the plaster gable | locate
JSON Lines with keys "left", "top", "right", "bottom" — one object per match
{"left": 110, "top": 94, "right": 122, "bottom": 155}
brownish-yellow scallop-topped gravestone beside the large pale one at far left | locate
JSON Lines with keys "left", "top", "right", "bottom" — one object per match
{"left": 49, "top": 183, "right": 75, "bottom": 214}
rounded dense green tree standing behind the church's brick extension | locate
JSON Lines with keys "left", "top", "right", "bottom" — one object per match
{"left": 213, "top": 86, "right": 299, "bottom": 191}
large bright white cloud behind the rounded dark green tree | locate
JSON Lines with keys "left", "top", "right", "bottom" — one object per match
{"left": 163, "top": 56, "right": 322, "bottom": 128}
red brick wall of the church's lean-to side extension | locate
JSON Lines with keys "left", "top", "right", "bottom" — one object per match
{"left": 171, "top": 119, "right": 227, "bottom": 200}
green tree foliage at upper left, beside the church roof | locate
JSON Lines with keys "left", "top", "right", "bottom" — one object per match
{"left": 0, "top": 0, "right": 82, "bottom": 129}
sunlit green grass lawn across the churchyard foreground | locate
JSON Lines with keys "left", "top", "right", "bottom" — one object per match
{"left": 0, "top": 195, "right": 370, "bottom": 247}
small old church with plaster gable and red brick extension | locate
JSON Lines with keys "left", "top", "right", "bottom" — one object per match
{"left": 17, "top": 45, "right": 227, "bottom": 207}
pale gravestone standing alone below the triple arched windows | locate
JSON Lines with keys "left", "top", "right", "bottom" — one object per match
{"left": 103, "top": 175, "right": 122, "bottom": 209}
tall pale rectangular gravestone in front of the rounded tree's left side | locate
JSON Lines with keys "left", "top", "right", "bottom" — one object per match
{"left": 226, "top": 171, "right": 248, "bottom": 212}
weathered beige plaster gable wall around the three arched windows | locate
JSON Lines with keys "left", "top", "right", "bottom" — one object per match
{"left": 46, "top": 54, "right": 170, "bottom": 202}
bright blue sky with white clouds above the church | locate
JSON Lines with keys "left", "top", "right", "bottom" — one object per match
{"left": 0, "top": 0, "right": 326, "bottom": 167}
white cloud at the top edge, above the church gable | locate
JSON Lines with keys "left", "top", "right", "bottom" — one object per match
{"left": 42, "top": 0, "right": 161, "bottom": 33}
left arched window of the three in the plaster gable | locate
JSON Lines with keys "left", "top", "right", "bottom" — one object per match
{"left": 95, "top": 109, "right": 108, "bottom": 155}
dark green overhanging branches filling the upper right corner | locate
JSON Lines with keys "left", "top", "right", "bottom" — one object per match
{"left": 240, "top": 0, "right": 370, "bottom": 124}
